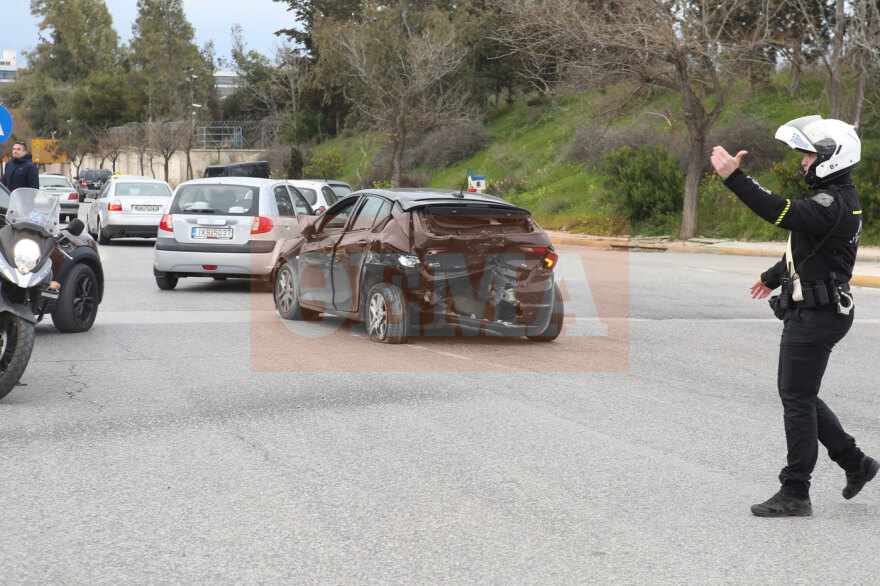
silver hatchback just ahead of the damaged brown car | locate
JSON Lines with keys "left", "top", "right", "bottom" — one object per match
{"left": 153, "top": 177, "right": 314, "bottom": 290}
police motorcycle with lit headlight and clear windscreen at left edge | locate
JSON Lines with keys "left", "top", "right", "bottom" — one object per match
{"left": 0, "top": 188, "right": 84, "bottom": 399}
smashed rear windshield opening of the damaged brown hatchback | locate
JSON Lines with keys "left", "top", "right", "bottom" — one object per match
{"left": 414, "top": 204, "right": 533, "bottom": 236}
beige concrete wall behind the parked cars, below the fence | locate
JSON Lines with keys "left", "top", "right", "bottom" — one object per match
{"left": 58, "top": 149, "right": 268, "bottom": 188}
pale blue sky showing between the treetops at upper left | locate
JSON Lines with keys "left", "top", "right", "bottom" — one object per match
{"left": 0, "top": 0, "right": 294, "bottom": 64}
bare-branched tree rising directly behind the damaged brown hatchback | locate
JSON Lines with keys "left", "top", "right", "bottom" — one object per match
{"left": 317, "top": 9, "right": 473, "bottom": 187}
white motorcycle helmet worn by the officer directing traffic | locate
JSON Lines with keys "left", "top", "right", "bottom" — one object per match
{"left": 776, "top": 116, "right": 862, "bottom": 187}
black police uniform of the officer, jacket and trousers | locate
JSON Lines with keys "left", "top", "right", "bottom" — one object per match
{"left": 724, "top": 169, "right": 864, "bottom": 498}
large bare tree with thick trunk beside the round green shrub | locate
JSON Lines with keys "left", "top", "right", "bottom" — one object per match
{"left": 494, "top": 0, "right": 783, "bottom": 238}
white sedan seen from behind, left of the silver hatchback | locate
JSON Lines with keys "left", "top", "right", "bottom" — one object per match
{"left": 86, "top": 176, "right": 171, "bottom": 244}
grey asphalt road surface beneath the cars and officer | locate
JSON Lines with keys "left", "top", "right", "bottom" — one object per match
{"left": 0, "top": 232, "right": 880, "bottom": 584}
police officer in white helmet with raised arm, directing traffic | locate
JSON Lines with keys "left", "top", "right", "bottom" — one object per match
{"left": 711, "top": 116, "right": 880, "bottom": 517}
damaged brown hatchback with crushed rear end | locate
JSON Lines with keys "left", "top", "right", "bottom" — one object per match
{"left": 274, "top": 188, "right": 564, "bottom": 344}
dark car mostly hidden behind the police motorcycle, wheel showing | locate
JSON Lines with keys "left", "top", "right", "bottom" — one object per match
{"left": 0, "top": 184, "right": 104, "bottom": 332}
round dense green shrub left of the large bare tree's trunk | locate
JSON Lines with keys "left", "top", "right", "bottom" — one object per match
{"left": 605, "top": 145, "right": 684, "bottom": 227}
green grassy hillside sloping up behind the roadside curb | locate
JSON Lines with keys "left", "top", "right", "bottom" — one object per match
{"left": 311, "top": 74, "right": 880, "bottom": 244}
